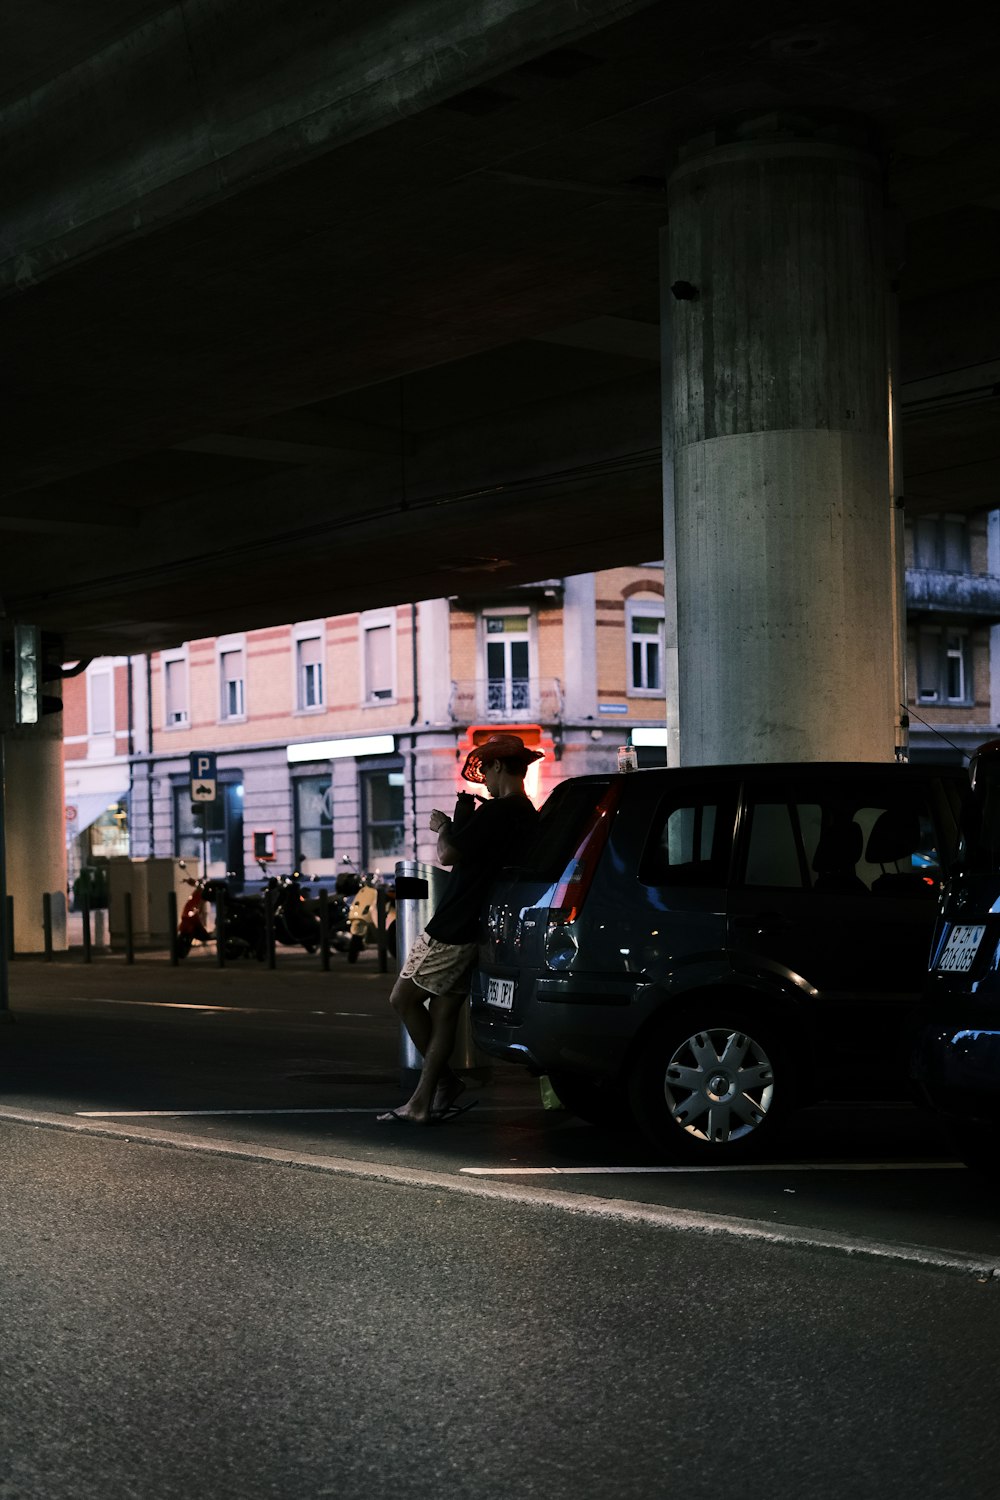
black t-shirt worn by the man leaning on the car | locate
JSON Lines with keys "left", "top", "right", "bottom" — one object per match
{"left": 427, "top": 794, "right": 538, "bottom": 944}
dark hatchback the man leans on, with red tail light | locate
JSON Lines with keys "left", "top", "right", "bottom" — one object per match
{"left": 472, "top": 764, "right": 969, "bottom": 1160}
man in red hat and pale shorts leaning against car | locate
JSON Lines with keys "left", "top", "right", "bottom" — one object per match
{"left": 378, "top": 734, "right": 541, "bottom": 1125}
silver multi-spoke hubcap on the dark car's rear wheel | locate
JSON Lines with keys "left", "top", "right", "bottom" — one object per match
{"left": 663, "top": 1028, "right": 774, "bottom": 1145}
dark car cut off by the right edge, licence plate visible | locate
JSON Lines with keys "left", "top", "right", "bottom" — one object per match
{"left": 912, "top": 741, "right": 1000, "bottom": 1176}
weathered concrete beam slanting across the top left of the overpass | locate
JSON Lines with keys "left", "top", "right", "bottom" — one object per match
{"left": 0, "top": 0, "right": 649, "bottom": 293}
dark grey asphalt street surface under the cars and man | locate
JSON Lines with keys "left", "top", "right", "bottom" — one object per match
{"left": 0, "top": 953, "right": 1000, "bottom": 1500}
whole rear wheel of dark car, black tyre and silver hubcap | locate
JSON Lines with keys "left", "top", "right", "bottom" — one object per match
{"left": 628, "top": 1005, "right": 787, "bottom": 1163}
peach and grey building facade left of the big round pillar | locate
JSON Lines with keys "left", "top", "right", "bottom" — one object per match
{"left": 64, "top": 564, "right": 666, "bottom": 884}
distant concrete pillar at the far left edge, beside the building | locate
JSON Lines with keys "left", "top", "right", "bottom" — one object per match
{"left": 4, "top": 714, "right": 66, "bottom": 953}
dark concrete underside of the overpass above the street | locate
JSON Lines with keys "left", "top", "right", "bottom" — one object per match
{"left": 0, "top": 0, "right": 1000, "bottom": 656}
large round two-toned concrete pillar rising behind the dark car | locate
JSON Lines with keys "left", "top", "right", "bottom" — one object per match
{"left": 666, "top": 122, "right": 897, "bottom": 765}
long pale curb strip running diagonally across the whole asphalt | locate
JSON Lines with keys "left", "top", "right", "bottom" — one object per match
{"left": 0, "top": 1109, "right": 1000, "bottom": 1284}
